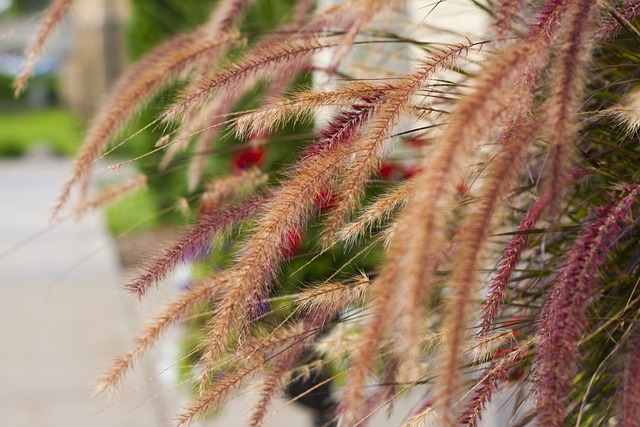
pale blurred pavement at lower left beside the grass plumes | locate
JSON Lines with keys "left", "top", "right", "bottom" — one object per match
{"left": 0, "top": 155, "right": 169, "bottom": 427}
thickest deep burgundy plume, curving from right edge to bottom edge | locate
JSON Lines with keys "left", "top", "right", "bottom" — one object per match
{"left": 533, "top": 184, "right": 640, "bottom": 427}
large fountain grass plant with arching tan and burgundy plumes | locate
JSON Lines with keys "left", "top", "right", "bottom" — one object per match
{"left": 16, "top": 0, "right": 640, "bottom": 427}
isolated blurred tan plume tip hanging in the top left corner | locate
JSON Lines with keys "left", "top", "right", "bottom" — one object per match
{"left": 13, "top": 0, "right": 73, "bottom": 97}
